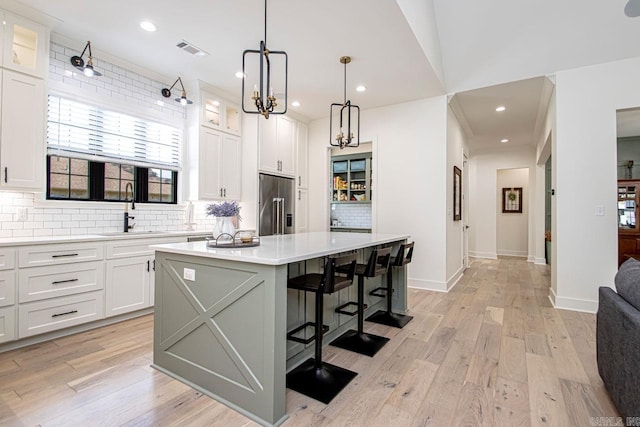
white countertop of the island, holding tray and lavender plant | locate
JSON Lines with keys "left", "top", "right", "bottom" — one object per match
{"left": 151, "top": 232, "right": 409, "bottom": 265}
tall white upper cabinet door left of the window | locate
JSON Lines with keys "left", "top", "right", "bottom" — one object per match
{"left": 0, "top": 70, "right": 45, "bottom": 190}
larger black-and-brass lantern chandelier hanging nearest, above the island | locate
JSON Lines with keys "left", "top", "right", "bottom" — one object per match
{"left": 242, "top": 0, "right": 289, "bottom": 119}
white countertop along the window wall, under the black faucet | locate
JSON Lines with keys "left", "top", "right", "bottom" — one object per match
{"left": 0, "top": 231, "right": 211, "bottom": 247}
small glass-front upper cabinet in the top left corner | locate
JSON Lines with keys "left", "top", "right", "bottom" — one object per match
{"left": 2, "top": 12, "right": 49, "bottom": 78}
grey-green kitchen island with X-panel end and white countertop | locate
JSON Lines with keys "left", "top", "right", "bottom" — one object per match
{"left": 152, "top": 232, "right": 408, "bottom": 425}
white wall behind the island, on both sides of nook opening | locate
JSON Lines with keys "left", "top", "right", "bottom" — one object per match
{"left": 309, "top": 96, "right": 450, "bottom": 290}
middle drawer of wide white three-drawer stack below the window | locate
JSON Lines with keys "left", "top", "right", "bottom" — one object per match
{"left": 18, "top": 261, "right": 104, "bottom": 303}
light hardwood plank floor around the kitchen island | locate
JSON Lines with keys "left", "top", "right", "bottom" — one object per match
{"left": 0, "top": 258, "right": 618, "bottom": 427}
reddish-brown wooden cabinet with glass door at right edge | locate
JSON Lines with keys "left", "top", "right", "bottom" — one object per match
{"left": 618, "top": 179, "right": 640, "bottom": 264}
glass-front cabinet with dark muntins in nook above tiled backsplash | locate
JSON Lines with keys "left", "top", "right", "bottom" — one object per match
{"left": 331, "top": 153, "right": 373, "bottom": 203}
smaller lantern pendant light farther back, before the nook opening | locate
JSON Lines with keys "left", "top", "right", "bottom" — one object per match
{"left": 329, "top": 56, "right": 360, "bottom": 149}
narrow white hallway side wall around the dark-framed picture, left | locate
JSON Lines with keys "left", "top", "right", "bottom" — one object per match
{"left": 445, "top": 108, "right": 469, "bottom": 289}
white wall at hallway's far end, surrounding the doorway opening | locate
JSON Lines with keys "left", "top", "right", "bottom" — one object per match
{"left": 469, "top": 147, "right": 544, "bottom": 259}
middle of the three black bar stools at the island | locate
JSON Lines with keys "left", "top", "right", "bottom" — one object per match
{"left": 331, "top": 248, "right": 391, "bottom": 357}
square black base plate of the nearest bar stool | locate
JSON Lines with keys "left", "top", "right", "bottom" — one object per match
{"left": 287, "top": 359, "right": 358, "bottom": 404}
